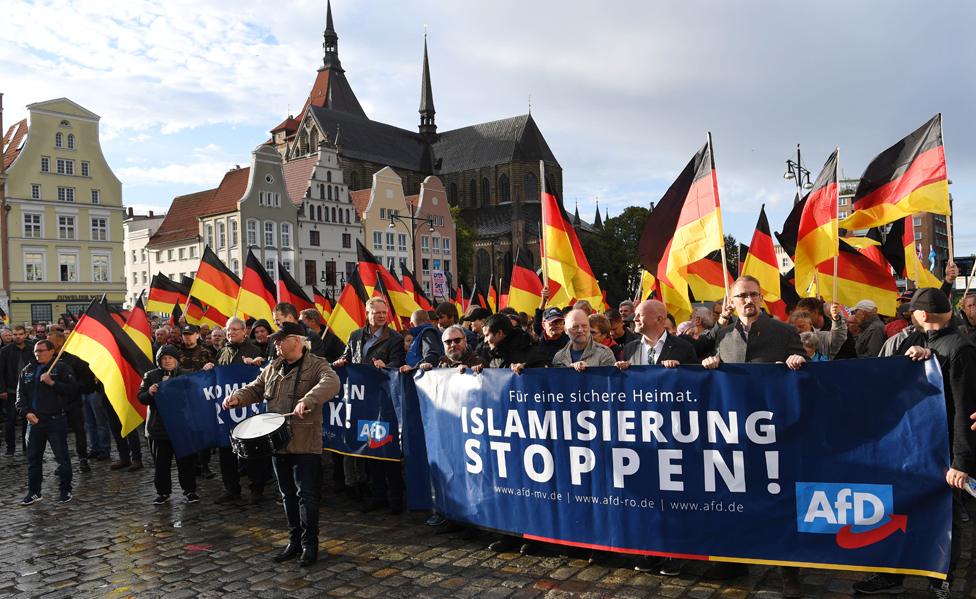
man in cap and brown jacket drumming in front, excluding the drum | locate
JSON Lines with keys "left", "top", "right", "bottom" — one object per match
{"left": 224, "top": 322, "right": 339, "bottom": 566}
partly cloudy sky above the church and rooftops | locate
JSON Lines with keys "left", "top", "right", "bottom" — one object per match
{"left": 0, "top": 0, "right": 976, "bottom": 255}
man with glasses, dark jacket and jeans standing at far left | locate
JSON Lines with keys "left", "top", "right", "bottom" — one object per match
{"left": 17, "top": 339, "right": 76, "bottom": 505}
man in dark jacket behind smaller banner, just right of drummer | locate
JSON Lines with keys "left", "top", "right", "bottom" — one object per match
{"left": 332, "top": 297, "right": 406, "bottom": 514}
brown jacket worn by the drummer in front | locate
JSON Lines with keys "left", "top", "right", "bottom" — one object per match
{"left": 232, "top": 351, "right": 339, "bottom": 454}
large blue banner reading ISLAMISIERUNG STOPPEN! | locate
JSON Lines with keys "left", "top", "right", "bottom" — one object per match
{"left": 404, "top": 358, "right": 951, "bottom": 577}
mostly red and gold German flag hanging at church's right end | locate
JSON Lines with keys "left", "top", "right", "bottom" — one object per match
{"left": 539, "top": 170, "right": 603, "bottom": 306}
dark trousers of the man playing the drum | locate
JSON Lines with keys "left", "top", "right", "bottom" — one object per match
{"left": 271, "top": 453, "right": 322, "bottom": 549}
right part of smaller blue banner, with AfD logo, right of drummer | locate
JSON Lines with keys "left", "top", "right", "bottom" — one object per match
{"left": 322, "top": 364, "right": 406, "bottom": 460}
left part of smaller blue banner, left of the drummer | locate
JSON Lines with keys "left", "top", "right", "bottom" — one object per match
{"left": 156, "top": 364, "right": 266, "bottom": 457}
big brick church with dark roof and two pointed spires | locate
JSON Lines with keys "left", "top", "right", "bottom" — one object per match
{"left": 270, "top": 3, "right": 590, "bottom": 287}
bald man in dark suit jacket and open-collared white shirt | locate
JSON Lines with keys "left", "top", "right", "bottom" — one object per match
{"left": 616, "top": 300, "right": 698, "bottom": 370}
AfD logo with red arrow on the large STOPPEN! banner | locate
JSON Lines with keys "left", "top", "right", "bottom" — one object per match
{"left": 796, "top": 482, "right": 908, "bottom": 549}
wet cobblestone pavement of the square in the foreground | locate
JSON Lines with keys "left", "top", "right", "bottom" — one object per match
{"left": 0, "top": 452, "right": 976, "bottom": 599}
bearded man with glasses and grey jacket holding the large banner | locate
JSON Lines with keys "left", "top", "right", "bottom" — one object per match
{"left": 702, "top": 275, "right": 807, "bottom": 597}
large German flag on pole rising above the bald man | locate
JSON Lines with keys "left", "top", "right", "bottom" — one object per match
{"left": 638, "top": 135, "right": 725, "bottom": 298}
